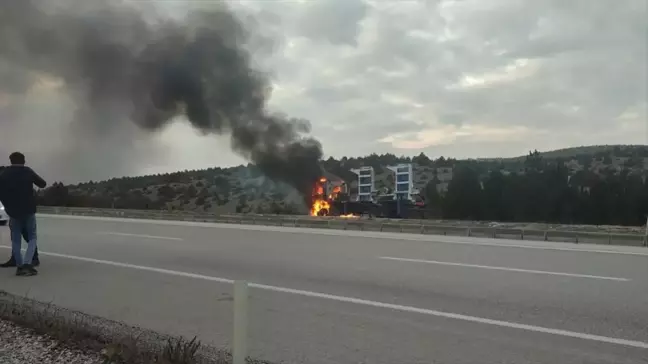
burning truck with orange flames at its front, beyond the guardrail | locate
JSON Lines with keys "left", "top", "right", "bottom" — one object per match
{"left": 310, "top": 169, "right": 426, "bottom": 218}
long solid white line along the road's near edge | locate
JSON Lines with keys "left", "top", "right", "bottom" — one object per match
{"left": 0, "top": 245, "right": 648, "bottom": 349}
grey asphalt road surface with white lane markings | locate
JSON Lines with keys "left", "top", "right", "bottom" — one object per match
{"left": 0, "top": 215, "right": 648, "bottom": 364}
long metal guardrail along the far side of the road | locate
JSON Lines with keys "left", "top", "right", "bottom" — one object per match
{"left": 39, "top": 206, "right": 648, "bottom": 247}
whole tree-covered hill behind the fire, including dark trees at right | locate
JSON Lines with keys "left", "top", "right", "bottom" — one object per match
{"left": 41, "top": 145, "right": 648, "bottom": 225}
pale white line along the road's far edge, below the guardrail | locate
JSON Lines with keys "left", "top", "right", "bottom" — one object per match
{"left": 39, "top": 214, "right": 648, "bottom": 257}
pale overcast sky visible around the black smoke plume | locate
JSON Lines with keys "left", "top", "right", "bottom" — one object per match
{"left": 0, "top": 0, "right": 648, "bottom": 182}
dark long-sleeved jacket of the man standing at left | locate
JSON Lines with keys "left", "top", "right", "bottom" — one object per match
{"left": 0, "top": 165, "right": 47, "bottom": 219}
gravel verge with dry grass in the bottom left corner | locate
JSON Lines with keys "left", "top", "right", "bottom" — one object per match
{"left": 0, "top": 291, "right": 271, "bottom": 364}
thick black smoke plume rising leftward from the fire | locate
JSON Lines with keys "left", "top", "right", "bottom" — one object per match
{"left": 0, "top": 0, "right": 322, "bottom": 196}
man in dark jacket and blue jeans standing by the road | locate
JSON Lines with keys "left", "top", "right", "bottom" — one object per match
{"left": 0, "top": 152, "right": 47, "bottom": 276}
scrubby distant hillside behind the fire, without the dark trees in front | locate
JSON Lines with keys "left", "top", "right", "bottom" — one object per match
{"left": 41, "top": 145, "right": 648, "bottom": 218}
